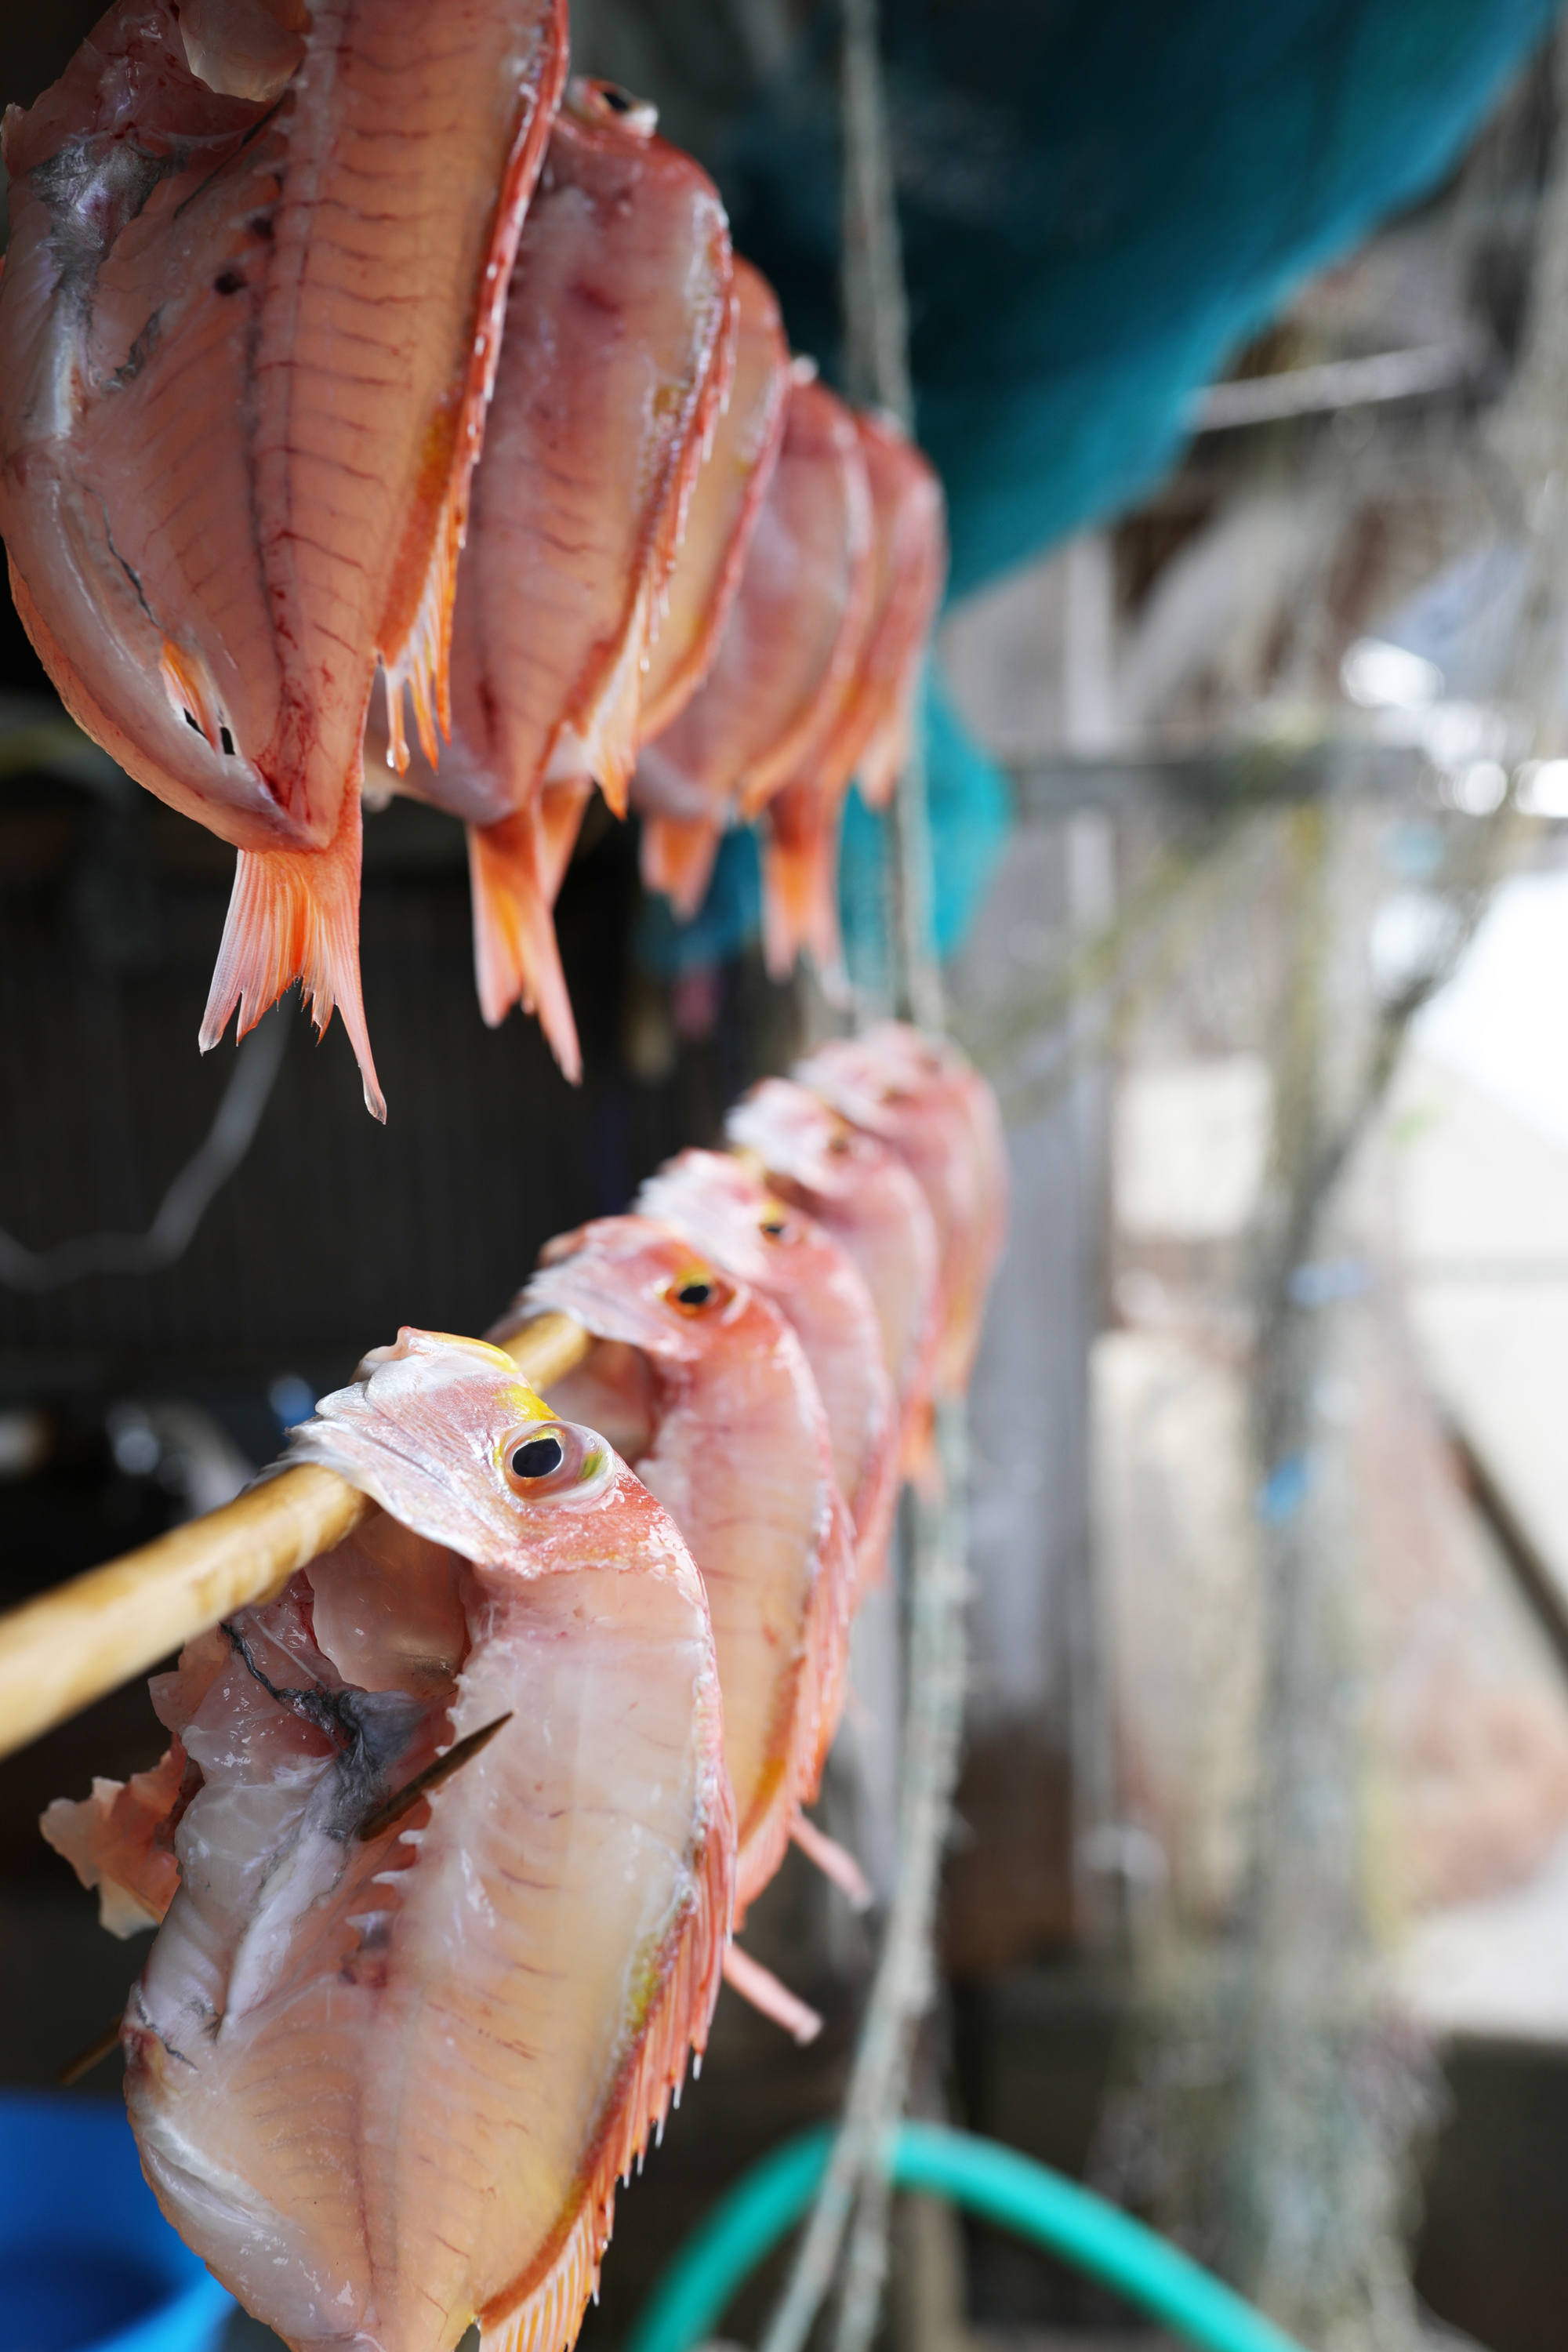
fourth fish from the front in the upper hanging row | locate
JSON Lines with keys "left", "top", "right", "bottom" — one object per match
{"left": 633, "top": 360, "right": 872, "bottom": 920}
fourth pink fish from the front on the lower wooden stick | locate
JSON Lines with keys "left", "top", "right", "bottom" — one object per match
{"left": 724, "top": 1077, "right": 942, "bottom": 1468}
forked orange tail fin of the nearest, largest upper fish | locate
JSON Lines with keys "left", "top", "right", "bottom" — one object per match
{"left": 200, "top": 779, "right": 386, "bottom": 1122}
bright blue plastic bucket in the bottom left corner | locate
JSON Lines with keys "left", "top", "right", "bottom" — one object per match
{"left": 0, "top": 2091, "right": 235, "bottom": 2352}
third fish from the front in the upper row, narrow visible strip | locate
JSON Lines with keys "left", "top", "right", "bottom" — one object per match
{"left": 637, "top": 254, "right": 789, "bottom": 741}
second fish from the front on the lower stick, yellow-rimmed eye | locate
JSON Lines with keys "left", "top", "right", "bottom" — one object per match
{"left": 512, "top": 1216, "right": 855, "bottom": 1924}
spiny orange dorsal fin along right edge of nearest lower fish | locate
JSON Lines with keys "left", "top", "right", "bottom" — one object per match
{"left": 480, "top": 1766, "right": 736, "bottom": 2352}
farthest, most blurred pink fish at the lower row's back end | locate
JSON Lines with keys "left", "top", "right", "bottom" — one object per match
{"left": 794, "top": 1021, "right": 1008, "bottom": 1395}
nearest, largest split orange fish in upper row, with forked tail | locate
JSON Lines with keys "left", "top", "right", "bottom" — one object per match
{"left": 0, "top": 0, "right": 567, "bottom": 1117}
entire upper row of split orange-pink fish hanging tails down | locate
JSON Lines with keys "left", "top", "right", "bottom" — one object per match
{"left": 0, "top": 0, "right": 945, "bottom": 1115}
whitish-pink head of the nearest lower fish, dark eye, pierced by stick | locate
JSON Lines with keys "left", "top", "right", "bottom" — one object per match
{"left": 287, "top": 1327, "right": 642, "bottom": 1571}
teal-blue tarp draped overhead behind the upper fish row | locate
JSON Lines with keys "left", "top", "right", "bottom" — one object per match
{"left": 648, "top": 0, "right": 1556, "bottom": 974}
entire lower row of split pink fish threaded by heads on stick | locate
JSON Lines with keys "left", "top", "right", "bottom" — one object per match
{"left": 45, "top": 1023, "right": 1006, "bottom": 2352}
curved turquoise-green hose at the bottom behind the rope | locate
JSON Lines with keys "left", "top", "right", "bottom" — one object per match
{"left": 626, "top": 2124, "right": 1300, "bottom": 2352}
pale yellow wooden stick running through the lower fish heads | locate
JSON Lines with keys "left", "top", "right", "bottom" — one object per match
{"left": 0, "top": 1315, "right": 590, "bottom": 1757}
